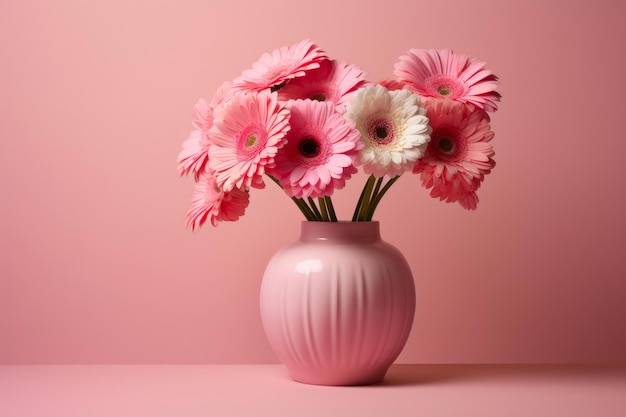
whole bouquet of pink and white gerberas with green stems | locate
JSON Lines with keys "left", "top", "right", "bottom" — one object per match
{"left": 178, "top": 40, "right": 500, "bottom": 229}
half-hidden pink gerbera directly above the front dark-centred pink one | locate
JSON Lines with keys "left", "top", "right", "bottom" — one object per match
{"left": 278, "top": 59, "right": 366, "bottom": 113}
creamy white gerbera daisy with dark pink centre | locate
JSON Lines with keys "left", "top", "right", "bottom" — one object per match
{"left": 345, "top": 85, "right": 431, "bottom": 178}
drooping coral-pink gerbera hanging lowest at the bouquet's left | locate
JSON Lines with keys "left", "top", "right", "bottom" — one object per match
{"left": 187, "top": 172, "right": 250, "bottom": 230}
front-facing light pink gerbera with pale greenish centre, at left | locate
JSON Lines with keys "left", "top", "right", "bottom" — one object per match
{"left": 209, "top": 90, "right": 289, "bottom": 192}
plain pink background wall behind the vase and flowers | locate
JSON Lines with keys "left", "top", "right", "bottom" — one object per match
{"left": 0, "top": 0, "right": 626, "bottom": 364}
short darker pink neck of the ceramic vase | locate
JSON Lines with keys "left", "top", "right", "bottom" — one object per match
{"left": 300, "top": 221, "right": 380, "bottom": 242}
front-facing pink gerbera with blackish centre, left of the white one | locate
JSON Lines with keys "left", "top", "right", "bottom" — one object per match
{"left": 268, "top": 99, "right": 362, "bottom": 198}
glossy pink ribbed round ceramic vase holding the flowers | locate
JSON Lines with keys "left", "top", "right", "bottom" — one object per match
{"left": 260, "top": 222, "right": 415, "bottom": 385}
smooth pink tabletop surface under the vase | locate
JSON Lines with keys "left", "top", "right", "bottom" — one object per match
{"left": 0, "top": 365, "right": 626, "bottom": 417}
